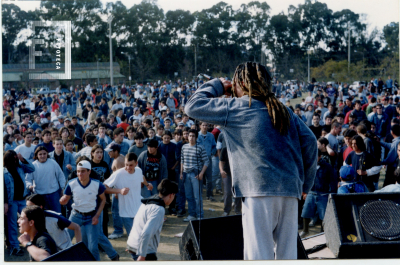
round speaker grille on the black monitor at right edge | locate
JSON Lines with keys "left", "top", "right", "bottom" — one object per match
{"left": 360, "top": 200, "right": 400, "bottom": 240}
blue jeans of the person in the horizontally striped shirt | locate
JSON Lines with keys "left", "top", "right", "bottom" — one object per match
{"left": 183, "top": 172, "right": 204, "bottom": 218}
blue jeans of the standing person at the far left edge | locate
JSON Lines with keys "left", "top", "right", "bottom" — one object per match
{"left": 7, "top": 200, "right": 26, "bottom": 248}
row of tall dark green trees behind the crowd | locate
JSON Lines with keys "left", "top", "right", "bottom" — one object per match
{"left": 2, "top": 0, "right": 399, "bottom": 82}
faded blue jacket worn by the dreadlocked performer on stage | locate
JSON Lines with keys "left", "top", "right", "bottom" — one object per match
{"left": 185, "top": 79, "right": 317, "bottom": 198}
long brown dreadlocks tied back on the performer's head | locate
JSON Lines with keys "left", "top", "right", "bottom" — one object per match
{"left": 232, "top": 62, "right": 290, "bottom": 134}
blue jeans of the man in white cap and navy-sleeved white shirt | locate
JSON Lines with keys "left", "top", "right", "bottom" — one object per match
{"left": 68, "top": 211, "right": 102, "bottom": 261}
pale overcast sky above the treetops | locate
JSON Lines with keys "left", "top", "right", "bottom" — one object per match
{"left": 10, "top": 0, "right": 399, "bottom": 32}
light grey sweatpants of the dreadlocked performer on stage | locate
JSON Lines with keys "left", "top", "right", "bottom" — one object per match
{"left": 242, "top": 196, "right": 298, "bottom": 260}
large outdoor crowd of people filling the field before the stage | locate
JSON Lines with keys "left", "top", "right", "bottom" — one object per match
{"left": 3, "top": 72, "right": 400, "bottom": 261}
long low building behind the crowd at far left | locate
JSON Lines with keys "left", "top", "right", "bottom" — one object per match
{"left": 2, "top": 62, "right": 125, "bottom": 89}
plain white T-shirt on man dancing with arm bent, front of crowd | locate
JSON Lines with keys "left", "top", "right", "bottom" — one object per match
{"left": 104, "top": 167, "right": 143, "bottom": 218}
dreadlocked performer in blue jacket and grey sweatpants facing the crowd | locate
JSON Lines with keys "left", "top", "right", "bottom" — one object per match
{"left": 185, "top": 62, "right": 317, "bottom": 260}
